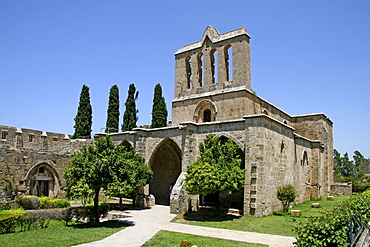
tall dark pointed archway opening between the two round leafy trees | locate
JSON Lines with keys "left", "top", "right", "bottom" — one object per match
{"left": 149, "top": 138, "right": 181, "bottom": 205}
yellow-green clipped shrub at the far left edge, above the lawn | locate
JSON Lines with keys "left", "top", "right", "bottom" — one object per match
{"left": 0, "top": 209, "right": 25, "bottom": 233}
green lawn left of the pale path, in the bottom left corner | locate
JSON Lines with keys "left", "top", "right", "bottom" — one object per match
{"left": 0, "top": 221, "right": 127, "bottom": 247}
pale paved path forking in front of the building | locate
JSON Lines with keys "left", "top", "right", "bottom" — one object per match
{"left": 74, "top": 205, "right": 295, "bottom": 247}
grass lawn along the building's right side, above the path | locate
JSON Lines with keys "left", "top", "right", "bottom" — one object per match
{"left": 173, "top": 196, "right": 349, "bottom": 237}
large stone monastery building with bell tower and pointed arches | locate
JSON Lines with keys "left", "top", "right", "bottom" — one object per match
{"left": 0, "top": 26, "right": 333, "bottom": 216}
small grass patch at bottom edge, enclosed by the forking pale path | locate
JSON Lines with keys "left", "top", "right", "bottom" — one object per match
{"left": 142, "top": 231, "right": 267, "bottom": 247}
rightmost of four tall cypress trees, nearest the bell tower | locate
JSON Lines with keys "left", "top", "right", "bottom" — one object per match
{"left": 151, "top": 83, "right": 168, "bottom": 128}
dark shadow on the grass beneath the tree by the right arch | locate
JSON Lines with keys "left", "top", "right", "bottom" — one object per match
{"left": 183, "top": 208, "right": 241, "bottom": 222}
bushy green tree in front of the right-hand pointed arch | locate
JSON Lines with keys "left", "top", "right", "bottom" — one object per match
{"left": 184, "top": 134, "right": 245, "bottom": 209}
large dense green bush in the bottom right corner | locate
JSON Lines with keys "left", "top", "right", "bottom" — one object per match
{"left": 295, "top": 196, "right": 370, "bottom": 247}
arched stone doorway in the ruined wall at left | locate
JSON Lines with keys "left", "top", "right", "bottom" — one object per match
{"left": 26, "top": 161, "right": 60, "bottom": 197}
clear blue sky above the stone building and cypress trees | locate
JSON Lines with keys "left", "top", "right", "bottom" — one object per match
{"left": 0, "top": 0, "right": 370, "bottom": 157}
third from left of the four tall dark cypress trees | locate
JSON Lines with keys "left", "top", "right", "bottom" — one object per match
{"left": 122, "top": 84, "right": 139, "bottom": 131}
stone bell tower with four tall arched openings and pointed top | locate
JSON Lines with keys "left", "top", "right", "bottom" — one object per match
{"left": 172, "top": 26, "right": 251, "bottom": 124}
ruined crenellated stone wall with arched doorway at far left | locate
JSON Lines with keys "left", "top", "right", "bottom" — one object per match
{"left": 0, "top": 126, "right": 92, "bottom": 201}
